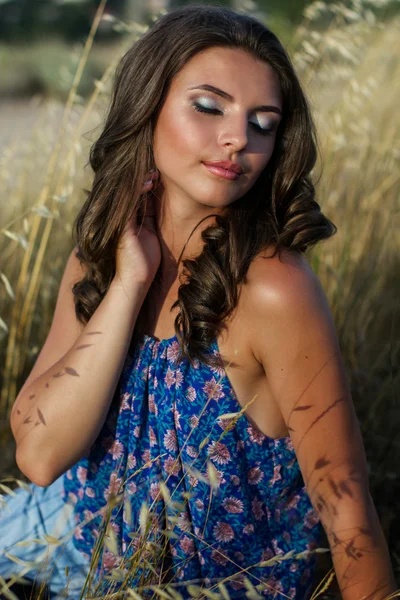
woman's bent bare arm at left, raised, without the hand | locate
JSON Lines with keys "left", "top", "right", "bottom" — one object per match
{"left": 10, "top": 248, "right": 149, "bottom": 486}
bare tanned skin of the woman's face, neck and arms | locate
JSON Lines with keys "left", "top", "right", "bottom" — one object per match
{"left": 12, "top": 48, "right": 396, "bottom": 600}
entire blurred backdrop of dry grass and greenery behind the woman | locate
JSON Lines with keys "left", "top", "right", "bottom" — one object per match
{"left": 0, "top": 0, "right": 400, "bottom": 597}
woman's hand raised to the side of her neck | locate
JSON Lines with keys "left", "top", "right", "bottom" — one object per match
{"left": 115, "top": 169, "right": 161, "bottom": 286}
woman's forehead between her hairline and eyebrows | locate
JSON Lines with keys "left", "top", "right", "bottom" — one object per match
{"left": 170, "top": 47, "right": 281, "bottom": 105}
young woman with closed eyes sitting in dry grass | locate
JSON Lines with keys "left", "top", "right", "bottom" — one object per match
{"left": 0, "top": 5, "right": 395, "bottom": 600}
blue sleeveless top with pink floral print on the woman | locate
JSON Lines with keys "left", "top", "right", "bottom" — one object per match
{"left": 63, "top": 334, "right": 321, "bottom": 599}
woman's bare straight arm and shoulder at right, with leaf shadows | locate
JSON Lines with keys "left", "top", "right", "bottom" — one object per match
{"left": 249, "top": 254, "right": 396, "bottom": 600}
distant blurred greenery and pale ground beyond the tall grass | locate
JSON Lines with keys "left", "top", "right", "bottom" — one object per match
{"left": 0, "top": 0, "right": 312, "bottom": 145}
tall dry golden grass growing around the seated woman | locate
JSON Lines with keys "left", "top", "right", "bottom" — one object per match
{"left": 0, "top": 0, "right": 400, "bottom": 600}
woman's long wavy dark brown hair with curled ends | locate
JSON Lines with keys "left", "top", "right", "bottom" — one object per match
{"left": 73, "top": 4, "right": 337, "bottom": 365}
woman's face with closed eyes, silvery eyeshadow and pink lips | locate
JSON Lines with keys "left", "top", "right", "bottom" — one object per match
{"left": 153, "top": 47, "right": 282, "bottom": 208}
